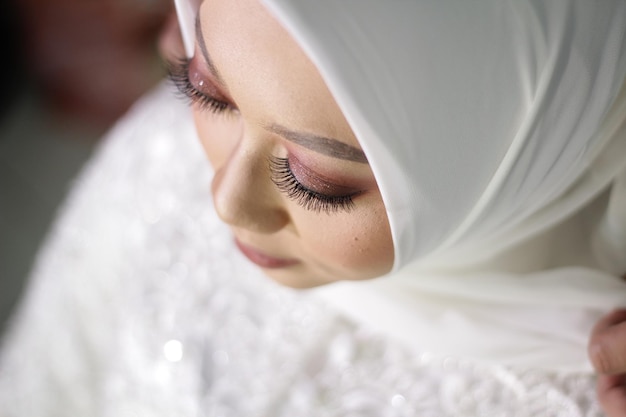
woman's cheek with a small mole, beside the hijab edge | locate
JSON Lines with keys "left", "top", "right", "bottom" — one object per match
{"left": 300, "top": 196, "right": 394, "bottom": 279}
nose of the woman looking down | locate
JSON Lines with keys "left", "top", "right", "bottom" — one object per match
{"left": 211, "top": 148, "right": 289, "bottom": 234}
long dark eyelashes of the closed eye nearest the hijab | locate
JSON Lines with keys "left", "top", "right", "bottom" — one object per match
{"left": 269, "top": 157, "right": 354, "bottom": 214}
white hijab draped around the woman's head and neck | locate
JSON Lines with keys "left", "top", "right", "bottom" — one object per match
{"left": 176, "top": 0, "right": 626, "bottom": 369}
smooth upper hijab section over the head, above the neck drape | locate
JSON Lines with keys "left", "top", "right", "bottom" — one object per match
{"left": 258, "top": 0, "right": 626, "bottom": 270}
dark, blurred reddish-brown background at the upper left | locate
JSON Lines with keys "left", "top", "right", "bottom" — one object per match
{"left": 0, "top": 0, "right": 173, "bottom": 332}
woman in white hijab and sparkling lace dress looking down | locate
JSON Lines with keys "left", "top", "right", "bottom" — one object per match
{"left": 3, "top": 0, "right": 626, "bottom": 416}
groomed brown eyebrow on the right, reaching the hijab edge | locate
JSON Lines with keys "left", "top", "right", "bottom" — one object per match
{"left": 266, "top": 124, "right": 367, "bottom": 164}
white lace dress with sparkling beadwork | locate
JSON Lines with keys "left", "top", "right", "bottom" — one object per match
{"left": 0, "top": 87, "right": 602, "bottom": 417}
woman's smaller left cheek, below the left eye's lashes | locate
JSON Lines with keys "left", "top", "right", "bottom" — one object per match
{"left": 193, "top": 109, "right": 243, "bottom": 170}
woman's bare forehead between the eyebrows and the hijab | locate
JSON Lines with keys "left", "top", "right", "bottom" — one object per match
{"left": 200, "top": 0, "right": 358, "bottom": 147}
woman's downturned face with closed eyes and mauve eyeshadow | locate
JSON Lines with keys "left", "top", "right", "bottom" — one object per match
{"left": 174, "top": 0, "right": 393, "bottom": 288}
